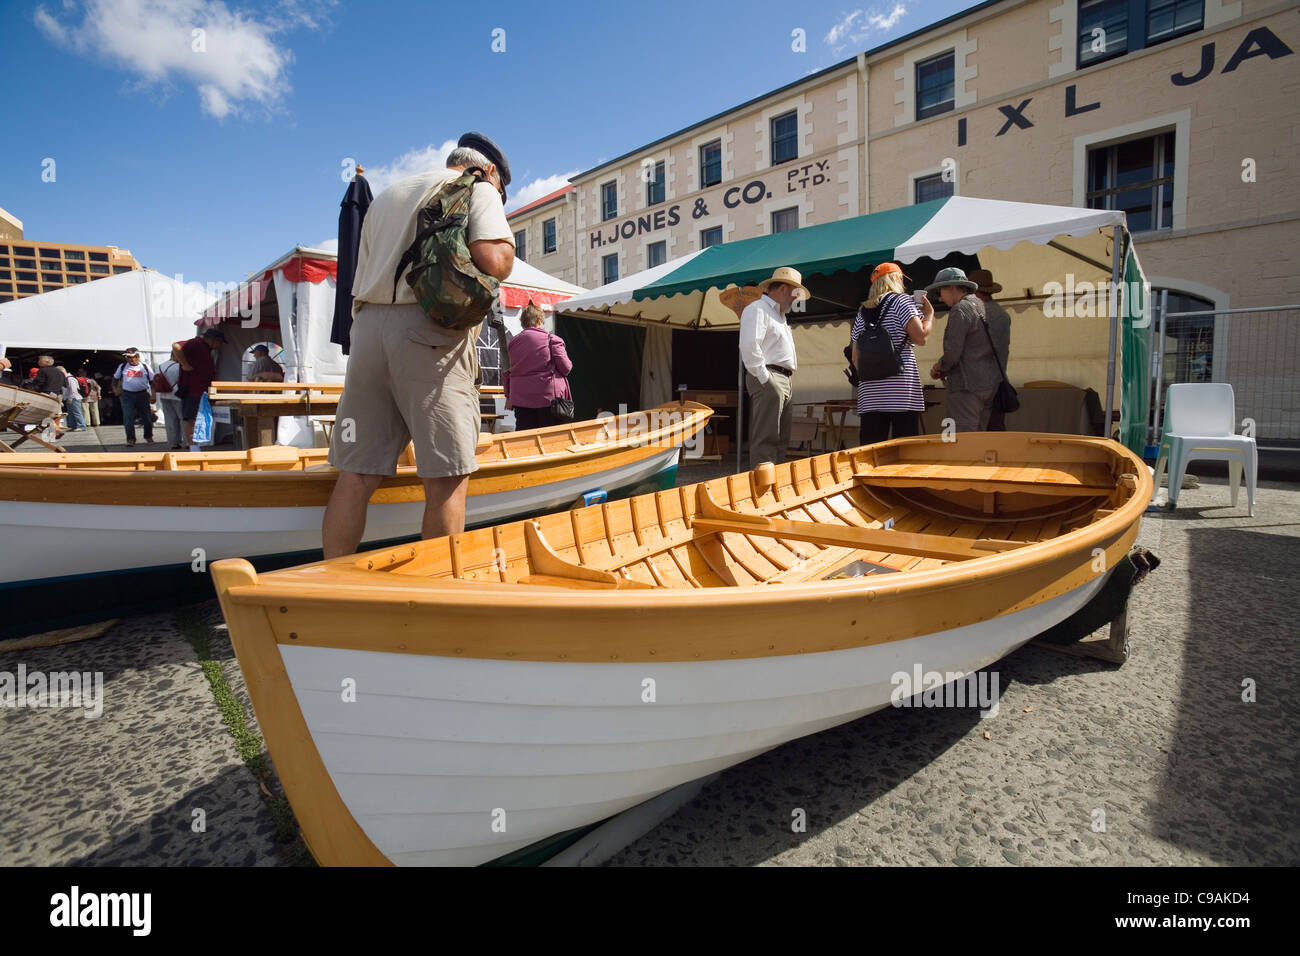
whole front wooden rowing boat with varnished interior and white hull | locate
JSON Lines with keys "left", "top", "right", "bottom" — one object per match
{"left": 212, "top": 433, "right": 1151, "bottom": 865}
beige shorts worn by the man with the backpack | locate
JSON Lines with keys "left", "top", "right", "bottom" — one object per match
{"left": 329, "top": 303, "right": 480, "bottom": 477}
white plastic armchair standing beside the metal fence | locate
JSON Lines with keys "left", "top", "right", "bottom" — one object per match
{"left": 1156, "top": 382, "right": 1260, "bottom": 518}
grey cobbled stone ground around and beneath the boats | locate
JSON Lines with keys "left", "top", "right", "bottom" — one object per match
{"left": 0, "top": 463, "right": 1300, "bottom": 866}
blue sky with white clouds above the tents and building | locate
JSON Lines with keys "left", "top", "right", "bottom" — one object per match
{"left": 0, "top": 0, "right": 975, "bottom": 282}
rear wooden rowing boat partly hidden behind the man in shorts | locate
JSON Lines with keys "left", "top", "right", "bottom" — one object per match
{"left": 0, "top": 402, "right": 712, "bottom": 636}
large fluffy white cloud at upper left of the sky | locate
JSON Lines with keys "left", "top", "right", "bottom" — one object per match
{"left": 34, "top": 0, "right": 337, "bottom": 118}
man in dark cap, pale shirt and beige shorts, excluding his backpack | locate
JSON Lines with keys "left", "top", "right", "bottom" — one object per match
{"left": 321, "top": 133, "right": 515, "bottom": 558}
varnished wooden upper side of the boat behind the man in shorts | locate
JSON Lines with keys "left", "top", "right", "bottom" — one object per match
{"left": 0, "top": 402, "right": 712, "bottom": 507}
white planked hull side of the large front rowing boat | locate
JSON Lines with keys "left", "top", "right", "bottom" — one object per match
{"left": 278, "top": 575, "right": 1106, "bottom": 865}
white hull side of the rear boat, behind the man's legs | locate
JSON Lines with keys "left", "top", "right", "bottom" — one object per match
{"left": 0, "top": 447, "right": 680, "bottom": 587}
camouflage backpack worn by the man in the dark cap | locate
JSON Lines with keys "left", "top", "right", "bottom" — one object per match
{"left": 393, "top": 168, "right": 501, "bottom": 330}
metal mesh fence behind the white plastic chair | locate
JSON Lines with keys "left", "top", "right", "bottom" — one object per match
{"left": 1148, "top": 303, "right": 1300, "bottom": 449}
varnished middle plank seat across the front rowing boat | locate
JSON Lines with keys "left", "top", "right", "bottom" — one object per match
{"left": 692, "top": 485, "right": 1028, "bottom": 561}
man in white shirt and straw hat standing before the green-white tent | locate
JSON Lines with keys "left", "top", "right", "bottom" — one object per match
{"left": 740, "top": 265, "right": 809, "bottom": 468}
